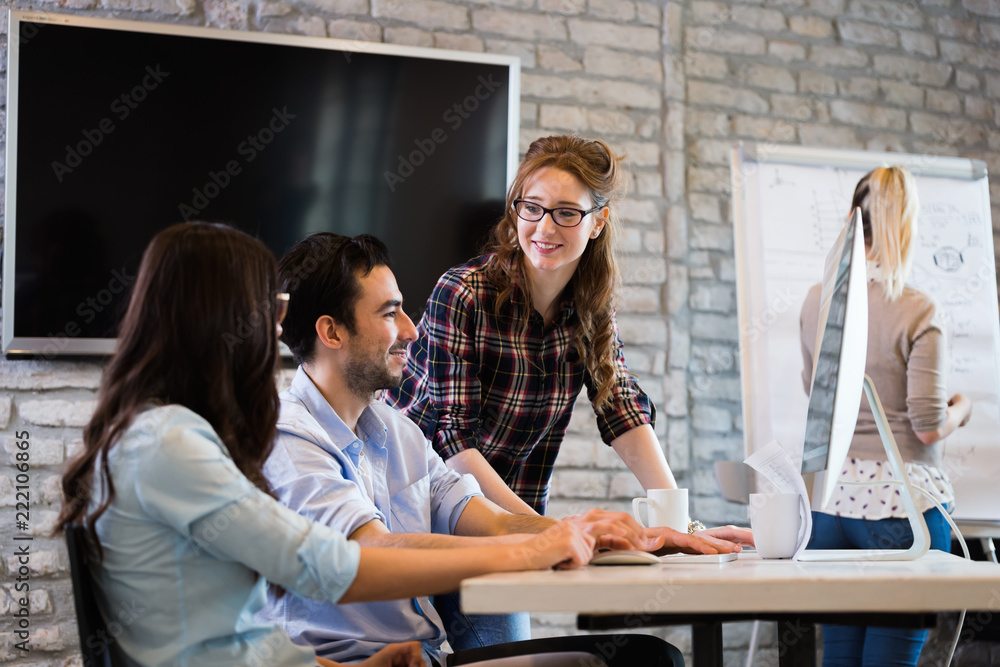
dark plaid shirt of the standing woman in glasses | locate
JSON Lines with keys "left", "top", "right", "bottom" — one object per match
{"left": 385, "top": 256, "right": 656, "bottom": 513}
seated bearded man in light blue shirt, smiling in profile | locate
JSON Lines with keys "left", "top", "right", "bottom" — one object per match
{"left": 258, "top": 234, "right": 748, "bottom": 665}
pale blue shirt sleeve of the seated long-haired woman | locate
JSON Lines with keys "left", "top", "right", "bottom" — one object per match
{"left": 137, "top": 422, "right": 361, "bottom": 602}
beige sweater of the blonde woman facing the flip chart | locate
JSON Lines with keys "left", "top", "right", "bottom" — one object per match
{"left": 799, "top": 280, "right": 948, "bottom": 467}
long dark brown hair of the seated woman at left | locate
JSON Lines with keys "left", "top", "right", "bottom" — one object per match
{"left": 56, "top": 223, "right": 279, "bottom": 550}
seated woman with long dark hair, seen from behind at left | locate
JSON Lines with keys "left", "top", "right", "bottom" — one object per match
{"left": 58, "top": 223, "right": 594, "bottom": 666}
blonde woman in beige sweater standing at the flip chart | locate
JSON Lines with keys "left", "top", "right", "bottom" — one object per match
{"left": 800, "top": 167, "right": 972, "bottom": 667}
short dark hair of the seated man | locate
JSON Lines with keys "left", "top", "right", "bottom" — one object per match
{"left": 278, "top": 232, "right": 392, "bottom": 364}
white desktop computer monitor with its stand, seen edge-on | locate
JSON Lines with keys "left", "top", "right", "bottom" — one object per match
{"left": 800, "top": 209, "right": 930, "bottom": 560}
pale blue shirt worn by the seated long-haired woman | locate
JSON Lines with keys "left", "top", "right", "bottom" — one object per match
{"left": 89, "top": 405, "right": 361, "bottom": 667}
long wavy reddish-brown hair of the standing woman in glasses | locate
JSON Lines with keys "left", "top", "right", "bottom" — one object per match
{"left": 486, "top": 136, "right": 628, "bottom": 411}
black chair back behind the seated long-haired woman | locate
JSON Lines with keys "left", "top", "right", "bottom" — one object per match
{"left": 66, "top": 524, "right": 125, "bottom": 667}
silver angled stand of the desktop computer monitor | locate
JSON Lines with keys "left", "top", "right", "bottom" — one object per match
{"left": 799, "top": 374, "right": 931, "bottom": 561}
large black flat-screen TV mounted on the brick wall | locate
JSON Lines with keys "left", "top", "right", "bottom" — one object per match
{"left": 3, "top": 11, "right": 520, "bottom": 355}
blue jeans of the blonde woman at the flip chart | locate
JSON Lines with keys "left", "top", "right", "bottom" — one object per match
{"left": 809, "top": 509, "right": 951, "bottom": 667}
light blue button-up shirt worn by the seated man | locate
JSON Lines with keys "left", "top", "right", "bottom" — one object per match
{"left": 257, "top": 367, "right": 482, "bottom": 664}
